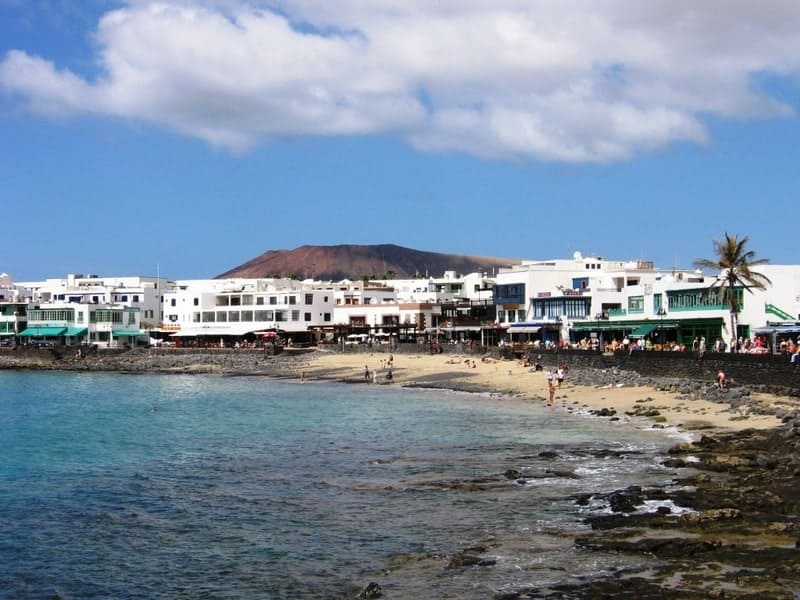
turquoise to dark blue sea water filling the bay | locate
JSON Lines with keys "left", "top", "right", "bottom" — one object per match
{"left": 0, "top": 371, "right": 674, "bottom": 599}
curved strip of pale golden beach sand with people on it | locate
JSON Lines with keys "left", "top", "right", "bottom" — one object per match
{"left": 303, "top": 351, "right": 780, "bottom": 431}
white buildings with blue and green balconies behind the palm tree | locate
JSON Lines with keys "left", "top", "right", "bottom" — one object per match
{"left": 495, "top": 253, "right": 800, "bottom": 348}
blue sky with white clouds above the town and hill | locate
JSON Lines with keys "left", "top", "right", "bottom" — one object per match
{"left": 0, "top": 0, "right": 800, "bottom": 281}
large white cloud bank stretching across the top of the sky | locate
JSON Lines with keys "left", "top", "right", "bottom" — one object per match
{"left": 0, "top": 0, "right": 800, "bottom": 162}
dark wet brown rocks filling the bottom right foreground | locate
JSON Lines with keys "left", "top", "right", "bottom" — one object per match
{"left": 564, "top": 426, "right": 800, "bottom": 599}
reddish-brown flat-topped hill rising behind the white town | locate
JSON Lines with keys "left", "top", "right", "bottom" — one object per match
{"left": 217, "top": 244, "right": 519, "bottom": 281}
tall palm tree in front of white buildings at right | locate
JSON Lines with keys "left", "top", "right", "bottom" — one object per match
{"left": 694, "top": 232, "right": 772, "bottom": 346}
